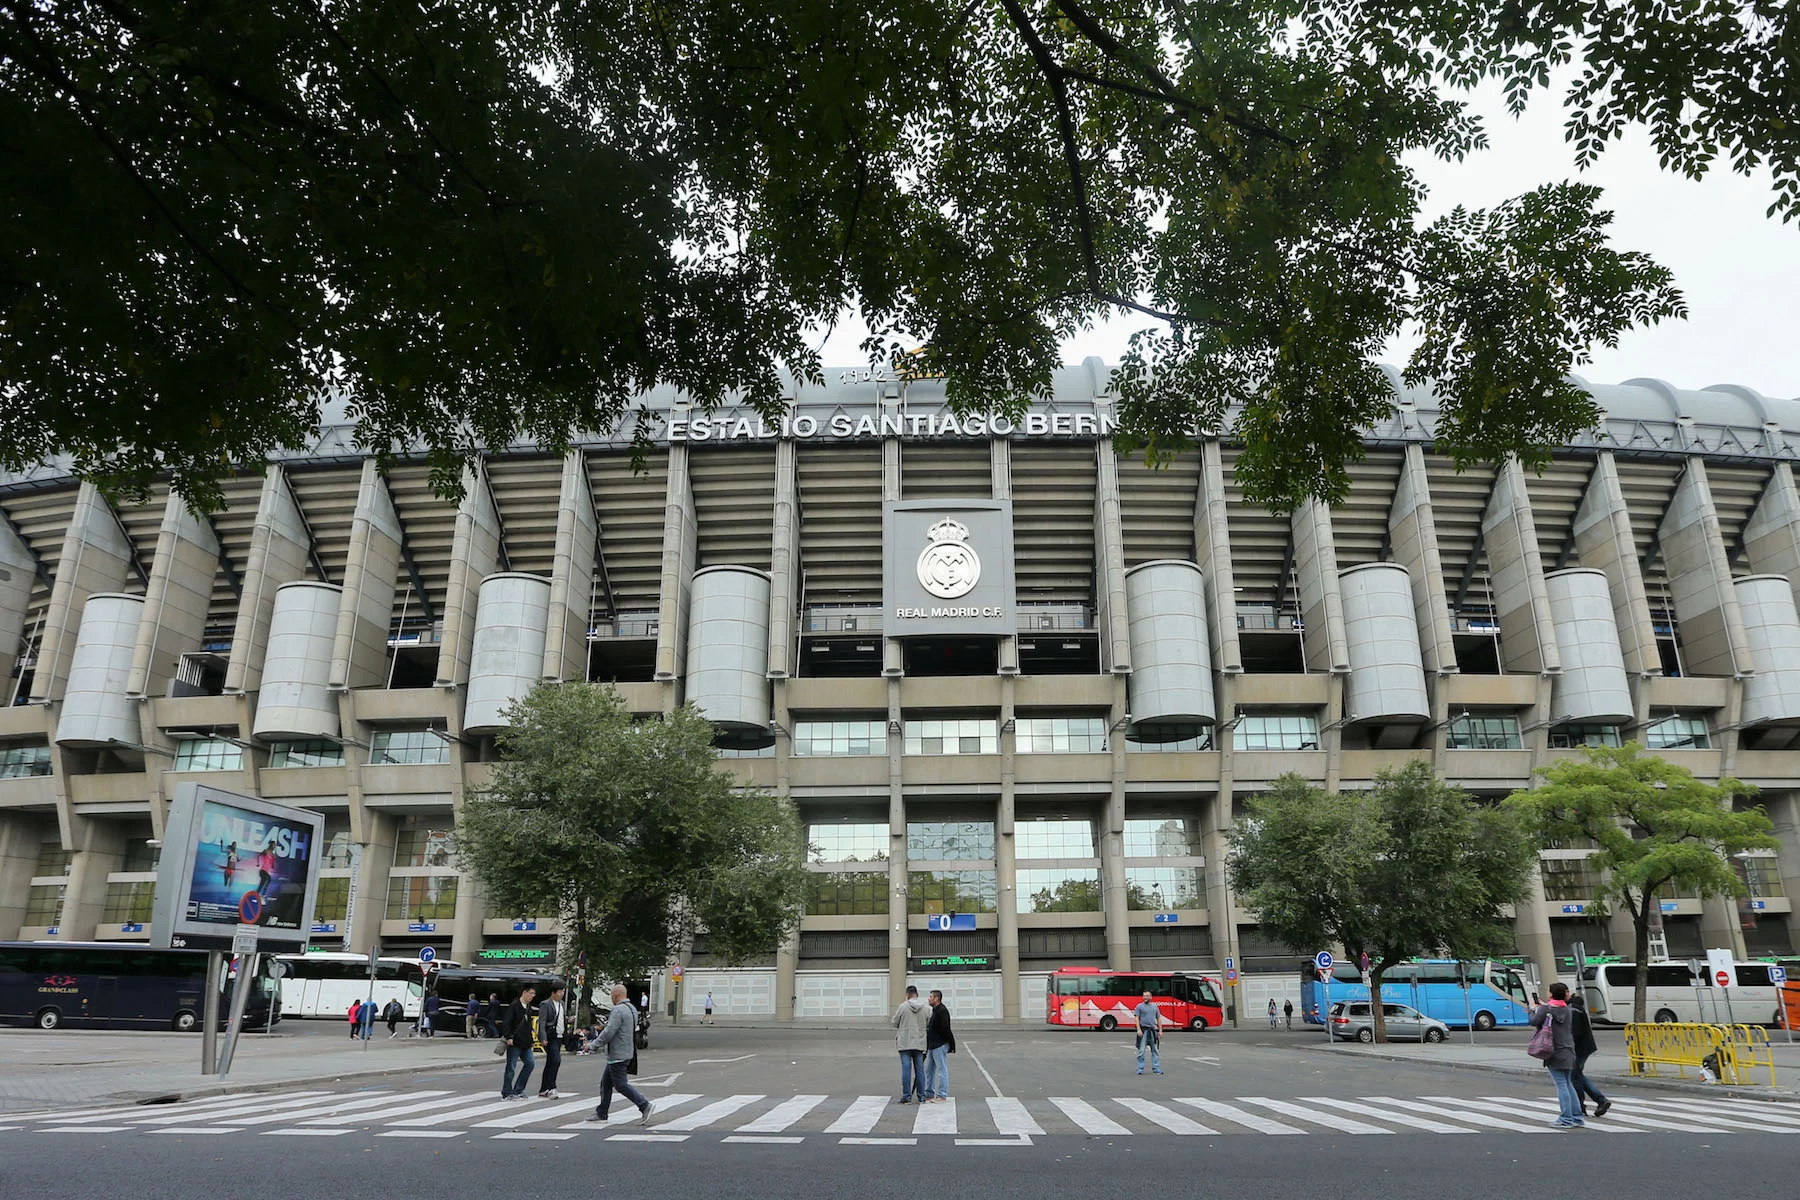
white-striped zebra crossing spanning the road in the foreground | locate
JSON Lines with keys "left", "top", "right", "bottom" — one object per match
{"left": 10, "top": 1088, "right": 1800, "bottom": 1146}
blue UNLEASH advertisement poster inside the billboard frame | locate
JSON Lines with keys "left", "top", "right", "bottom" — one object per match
{"left": 185, "top": 801, "right": 315, "bottom": 930}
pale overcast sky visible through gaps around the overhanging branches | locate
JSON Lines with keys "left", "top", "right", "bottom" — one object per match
{"left": 826, "top": 77, "right": 1800, "bottom": 398}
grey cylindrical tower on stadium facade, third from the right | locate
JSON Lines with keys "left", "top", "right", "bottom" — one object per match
{"left": 1337, "top": 563, "right": 1431, "bottom": 721}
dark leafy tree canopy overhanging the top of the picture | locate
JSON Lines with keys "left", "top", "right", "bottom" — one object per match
{"left": 0, "top": 0, "right": 1692, "bottom": 509}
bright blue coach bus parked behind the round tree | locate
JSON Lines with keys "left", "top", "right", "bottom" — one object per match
{"left": 1300, "top": 959, "right": 1532, "bottom": 1029}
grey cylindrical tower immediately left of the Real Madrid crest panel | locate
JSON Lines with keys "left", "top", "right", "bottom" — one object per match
{"left": 688, "top": 567, "right": 774, "bottom": 747}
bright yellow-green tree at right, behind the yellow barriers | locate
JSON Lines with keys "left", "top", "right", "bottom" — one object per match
{"left": 1507, "top": 741, "right": 1778, "bottom": 1022}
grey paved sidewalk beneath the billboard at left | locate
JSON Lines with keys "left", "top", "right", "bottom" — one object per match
{"left": 0, "top": 1029, "right": 499, "bottom": 1114}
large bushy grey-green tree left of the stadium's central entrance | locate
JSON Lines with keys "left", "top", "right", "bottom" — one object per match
{"left": 457, "top": 684, "right": 806, "bottom": 1007}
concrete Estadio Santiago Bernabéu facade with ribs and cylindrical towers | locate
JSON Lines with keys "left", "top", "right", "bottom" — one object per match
{"left": 0, "top": 360, "right": 1800, "bottom": 1022}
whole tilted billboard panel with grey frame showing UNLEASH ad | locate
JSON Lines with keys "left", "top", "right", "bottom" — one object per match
{"left": 149, "top": 783, "right": 326, "bottom": 950}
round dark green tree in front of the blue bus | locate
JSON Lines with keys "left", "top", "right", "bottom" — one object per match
{"left": 1226, "top": 763, "right": 1535, "bottom": 1042}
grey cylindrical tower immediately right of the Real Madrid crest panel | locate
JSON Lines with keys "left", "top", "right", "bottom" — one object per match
{"left": 1125, "top": 558, "right": 1219, "bottom": 741}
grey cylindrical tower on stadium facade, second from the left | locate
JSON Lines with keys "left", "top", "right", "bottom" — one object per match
{"left": 256, "top": 581, "right": 344, "bottom": 741}
